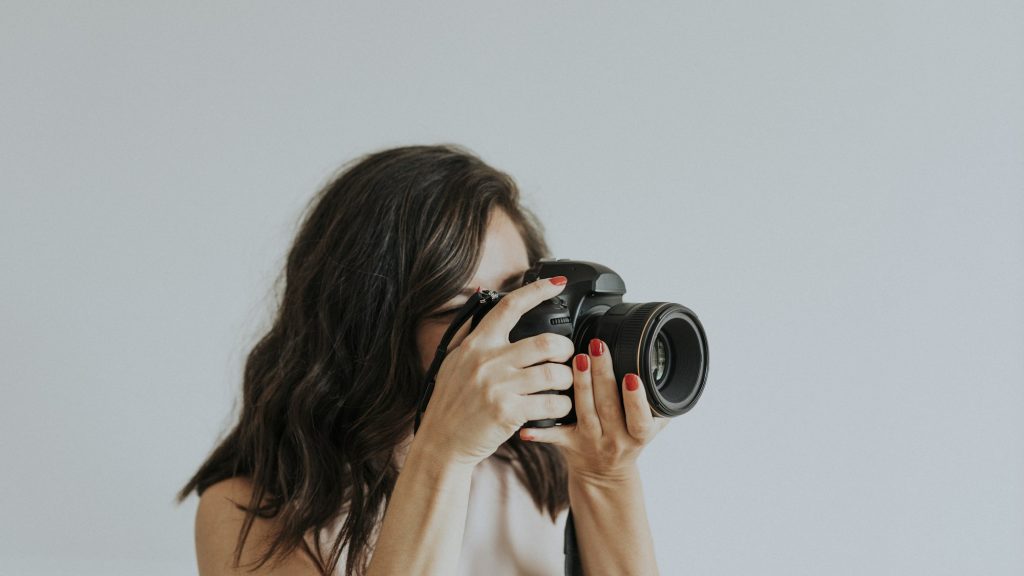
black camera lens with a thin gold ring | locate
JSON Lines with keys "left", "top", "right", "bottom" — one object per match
{"left": 579, "top": 302, "right": 708, "bottom": 417}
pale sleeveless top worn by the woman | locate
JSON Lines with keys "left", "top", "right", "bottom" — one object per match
{"left": 321, "top": 456, "right": 568, "bottom": 576}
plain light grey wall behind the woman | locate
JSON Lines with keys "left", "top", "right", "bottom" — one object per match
{"left": 0, "top": 0, "right": 1024, "bottom": 575}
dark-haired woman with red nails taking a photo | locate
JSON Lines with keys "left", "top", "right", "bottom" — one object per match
{"left": 178, "top": 146, "right": 669, "bottom": 576}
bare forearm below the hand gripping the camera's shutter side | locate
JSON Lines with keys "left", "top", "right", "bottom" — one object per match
{"left": 368, "top": 442, "right": 473, "bottom": 576}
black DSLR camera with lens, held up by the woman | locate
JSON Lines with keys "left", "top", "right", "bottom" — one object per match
{"left": 471, "top": 258, "right": 708, "bottom": 427}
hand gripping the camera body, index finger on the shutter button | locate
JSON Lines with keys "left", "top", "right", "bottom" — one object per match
{"left": 416, "top": 276, "right": 575, "bottom": 466}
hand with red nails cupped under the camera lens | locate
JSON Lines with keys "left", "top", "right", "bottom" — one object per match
{"left": 519, "top": 338, "right": 671, "bottom": 480}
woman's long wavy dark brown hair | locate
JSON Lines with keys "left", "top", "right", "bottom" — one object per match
{"left": 177, "top": 145, "right": 568, "bottom": 575}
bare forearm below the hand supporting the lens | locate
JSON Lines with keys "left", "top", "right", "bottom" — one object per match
{"left": 568, "top": 465, "right": 658, "bottom": 576}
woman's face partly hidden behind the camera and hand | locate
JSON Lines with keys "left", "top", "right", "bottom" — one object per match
{"left": 416, "top": 208, "right": 529, "bottom": 372}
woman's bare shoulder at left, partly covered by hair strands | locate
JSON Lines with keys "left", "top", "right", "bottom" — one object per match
{"left": 196, "top": 477, "right": 315, "bottom": 576}
